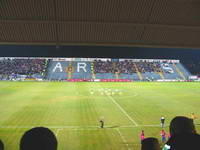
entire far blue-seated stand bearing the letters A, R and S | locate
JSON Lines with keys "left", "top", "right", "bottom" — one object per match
{"left": 0, "top": 58, "right": 192, "bottom": 81}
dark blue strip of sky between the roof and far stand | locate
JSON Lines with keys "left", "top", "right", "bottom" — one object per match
{"left": 0, "top": 45, "right": 200, "bottom": 60}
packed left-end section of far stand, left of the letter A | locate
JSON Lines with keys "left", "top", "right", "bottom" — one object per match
{"left": 0, "top": 58, "right": 48, "bottom": 80}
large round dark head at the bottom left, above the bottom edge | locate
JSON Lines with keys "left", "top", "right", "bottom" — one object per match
{"left": 20, "top": 127, "right": 57, "bottom": 150}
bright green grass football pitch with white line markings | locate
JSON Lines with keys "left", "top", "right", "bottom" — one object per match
{"left": 0, "top": 82, "right": 200, "bottom": 150}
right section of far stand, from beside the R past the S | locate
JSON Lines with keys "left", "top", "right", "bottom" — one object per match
{"left": 94, "top": 60, "right": 190, "bottom": 80}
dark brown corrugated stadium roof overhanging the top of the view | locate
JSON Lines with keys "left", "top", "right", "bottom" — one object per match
{"left": 0, "top": 0, "right": 200, "bottom": 48}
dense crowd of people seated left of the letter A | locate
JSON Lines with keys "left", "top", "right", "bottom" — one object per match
{"left": 0, "top": 58, "right": 47, "bottom": 79}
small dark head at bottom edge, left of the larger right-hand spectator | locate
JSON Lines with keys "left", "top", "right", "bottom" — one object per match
{"left": 141, "top": 137, "right": 160, "bottom": 150}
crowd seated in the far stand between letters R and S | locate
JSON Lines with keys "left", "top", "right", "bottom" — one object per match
{"left": 94, "top": 60, "right": 162, "bottom": 74}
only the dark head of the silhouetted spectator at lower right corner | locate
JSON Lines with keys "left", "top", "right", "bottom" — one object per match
{"left": 170, "top": 116, "right": 196, "bottom": 136}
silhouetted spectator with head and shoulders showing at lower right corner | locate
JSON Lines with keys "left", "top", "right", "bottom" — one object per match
{"left": 163, "top": 116, "right": 200, "bottom": 150}
